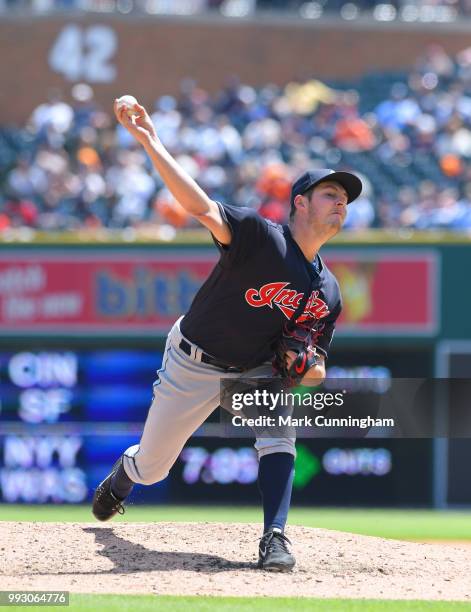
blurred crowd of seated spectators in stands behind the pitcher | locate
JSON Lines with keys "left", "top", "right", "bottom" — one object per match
{"left": 0, "top": 46, "right": 471, "bottom": 232}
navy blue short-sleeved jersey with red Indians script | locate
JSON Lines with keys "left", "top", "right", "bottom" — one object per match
{"left": 181, "top": 204, "right": 342, "bottom": 367}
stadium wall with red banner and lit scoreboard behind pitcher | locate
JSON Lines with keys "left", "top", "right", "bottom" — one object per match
{"left": 0, "top": 236, "right": 471, "bottom": 507}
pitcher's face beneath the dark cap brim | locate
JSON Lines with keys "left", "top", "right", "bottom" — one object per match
{"left": 307, "top": 181, "right": 348, "bottom": 236}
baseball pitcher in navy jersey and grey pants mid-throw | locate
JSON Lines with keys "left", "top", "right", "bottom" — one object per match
{"left": 93, "top": 101, "right": 362, "bottom": 571}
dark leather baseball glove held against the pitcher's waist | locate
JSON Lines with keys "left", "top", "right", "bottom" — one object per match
{"left": 272, "top": 321, "right": 318, "bottom": 386}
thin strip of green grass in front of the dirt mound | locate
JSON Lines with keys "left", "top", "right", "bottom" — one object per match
{"left": 67, "top": 595, "right": 471, "bottom": 612}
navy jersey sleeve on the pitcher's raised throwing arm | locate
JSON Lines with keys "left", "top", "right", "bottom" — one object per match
{"left": 213, "top": 202, "right": 268, "bottom": 267}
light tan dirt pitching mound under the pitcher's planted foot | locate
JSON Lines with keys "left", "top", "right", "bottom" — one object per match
{"left": 0, "top": 522, "right": 471, "bottom": 600}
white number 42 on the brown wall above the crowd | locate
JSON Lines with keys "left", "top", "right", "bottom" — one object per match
{"left": 48, "top": 24, "right": 118, "bottom": 83}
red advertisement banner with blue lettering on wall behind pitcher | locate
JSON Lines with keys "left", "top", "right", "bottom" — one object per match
{"left": 0, "top": 249, "right": 439, "bottom": 335}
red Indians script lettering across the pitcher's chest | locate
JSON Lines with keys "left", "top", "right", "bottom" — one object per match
{"left": 245, "top": 282, "right": 329, "bottom": 323}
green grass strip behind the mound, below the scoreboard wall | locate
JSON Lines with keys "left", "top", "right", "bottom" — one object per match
{"left": 0, "top": 504, "right": 471, "bottom": 540}
